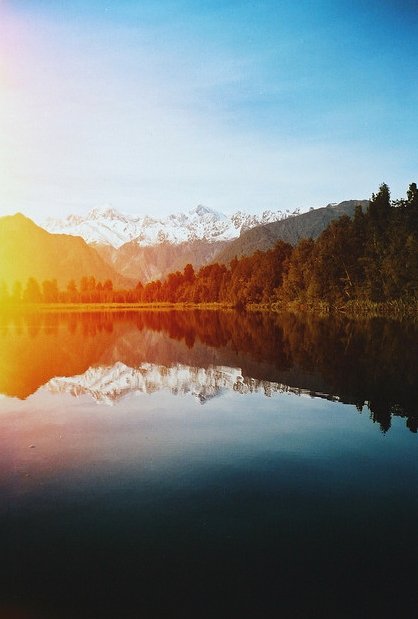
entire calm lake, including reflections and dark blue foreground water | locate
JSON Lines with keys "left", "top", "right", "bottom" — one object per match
{"left": 0, "top": 311, "right": 418, "bottom": 619}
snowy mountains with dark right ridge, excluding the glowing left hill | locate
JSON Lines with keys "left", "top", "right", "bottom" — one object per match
{"left": 40, "top": 200, "right": 368, "bottom": 282}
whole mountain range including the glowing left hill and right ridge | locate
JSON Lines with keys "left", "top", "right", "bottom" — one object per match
{"left": 0, "top": 200, "right": 368, "bottom": 288}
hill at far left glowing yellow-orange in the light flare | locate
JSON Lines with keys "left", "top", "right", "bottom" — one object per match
{"left": 0, "top": 213, "right": 133, "bottom": 288}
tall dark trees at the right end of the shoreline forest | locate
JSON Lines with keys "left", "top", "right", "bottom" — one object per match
{"left": 282, "top": 183, "right": 418, "bottom": 305}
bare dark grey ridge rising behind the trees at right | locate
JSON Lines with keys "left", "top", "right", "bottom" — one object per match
{"left": 215, "top": 200, "right": 369, "bottom": 263}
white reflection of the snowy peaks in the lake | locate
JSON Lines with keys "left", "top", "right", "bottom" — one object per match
{"left": 43, "top": 361, "right": 300, "bottom": 405}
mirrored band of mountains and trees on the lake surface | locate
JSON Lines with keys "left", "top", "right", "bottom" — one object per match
{"left": 0, "top": 311, "right": 418, "bottom": 432}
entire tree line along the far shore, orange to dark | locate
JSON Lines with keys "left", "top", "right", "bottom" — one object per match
{"left": 0, "top": 183, "right": 418, "bottom": 307}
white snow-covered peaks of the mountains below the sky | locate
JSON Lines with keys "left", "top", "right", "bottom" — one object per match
{"left": 42, "top": 204, "right": 298, "bottom": 248}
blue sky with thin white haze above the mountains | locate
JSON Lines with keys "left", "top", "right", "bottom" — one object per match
{"left": 0, "top": 0, "right": 418, "bottom": 220}
